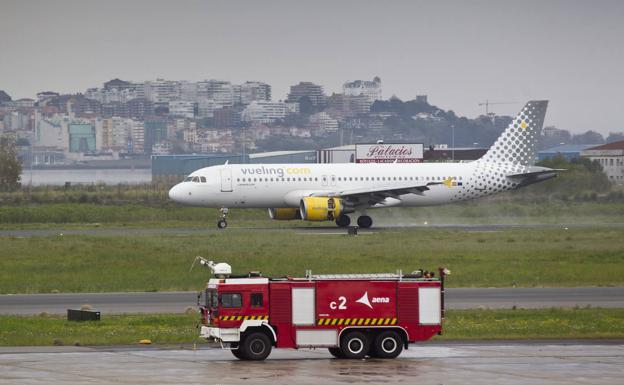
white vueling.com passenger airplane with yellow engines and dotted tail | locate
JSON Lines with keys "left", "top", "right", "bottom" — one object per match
{"left": 169, "top": 100, "right": 563, "bottom": 229}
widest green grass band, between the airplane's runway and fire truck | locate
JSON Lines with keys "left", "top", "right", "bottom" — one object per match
{"left": 0, "top": 227, "right": 624, "bottom": 293}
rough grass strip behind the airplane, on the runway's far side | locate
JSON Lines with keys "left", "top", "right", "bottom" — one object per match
{"left": 0, "top": 199, "right": 624, "bottom": 229}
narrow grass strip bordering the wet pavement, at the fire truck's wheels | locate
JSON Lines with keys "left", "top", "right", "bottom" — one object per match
{"left": 0, "top": 309, "right": 624, "bottom": 346}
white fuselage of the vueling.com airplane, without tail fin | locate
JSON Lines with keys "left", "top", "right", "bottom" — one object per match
{"left": 170, "top": 162, "right": 514, "bottom": 208}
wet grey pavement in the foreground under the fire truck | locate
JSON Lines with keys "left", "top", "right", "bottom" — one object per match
{"left": 0, "top": 341, "right": 624, "bottom": 385}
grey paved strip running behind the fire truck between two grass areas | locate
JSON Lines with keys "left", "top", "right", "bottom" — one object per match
{"left": 0, "top": 287, "right": 624, "bottom": 315}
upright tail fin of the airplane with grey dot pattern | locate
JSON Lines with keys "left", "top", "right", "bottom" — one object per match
{"left": 481, "top": 100, "right": 548, "bottom": 166}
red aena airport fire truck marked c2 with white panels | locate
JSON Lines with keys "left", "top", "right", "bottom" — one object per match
{"left": 197, "top": 257, "right": 449, "bottom": 360}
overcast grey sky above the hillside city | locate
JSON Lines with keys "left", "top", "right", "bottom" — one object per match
{"left": 0, "top": 0, "right": 624, "bottom": 134}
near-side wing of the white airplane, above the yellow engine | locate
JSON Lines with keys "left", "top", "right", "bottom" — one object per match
{"left": 312, "top": 182, "right": 444, "bottom": 206}
